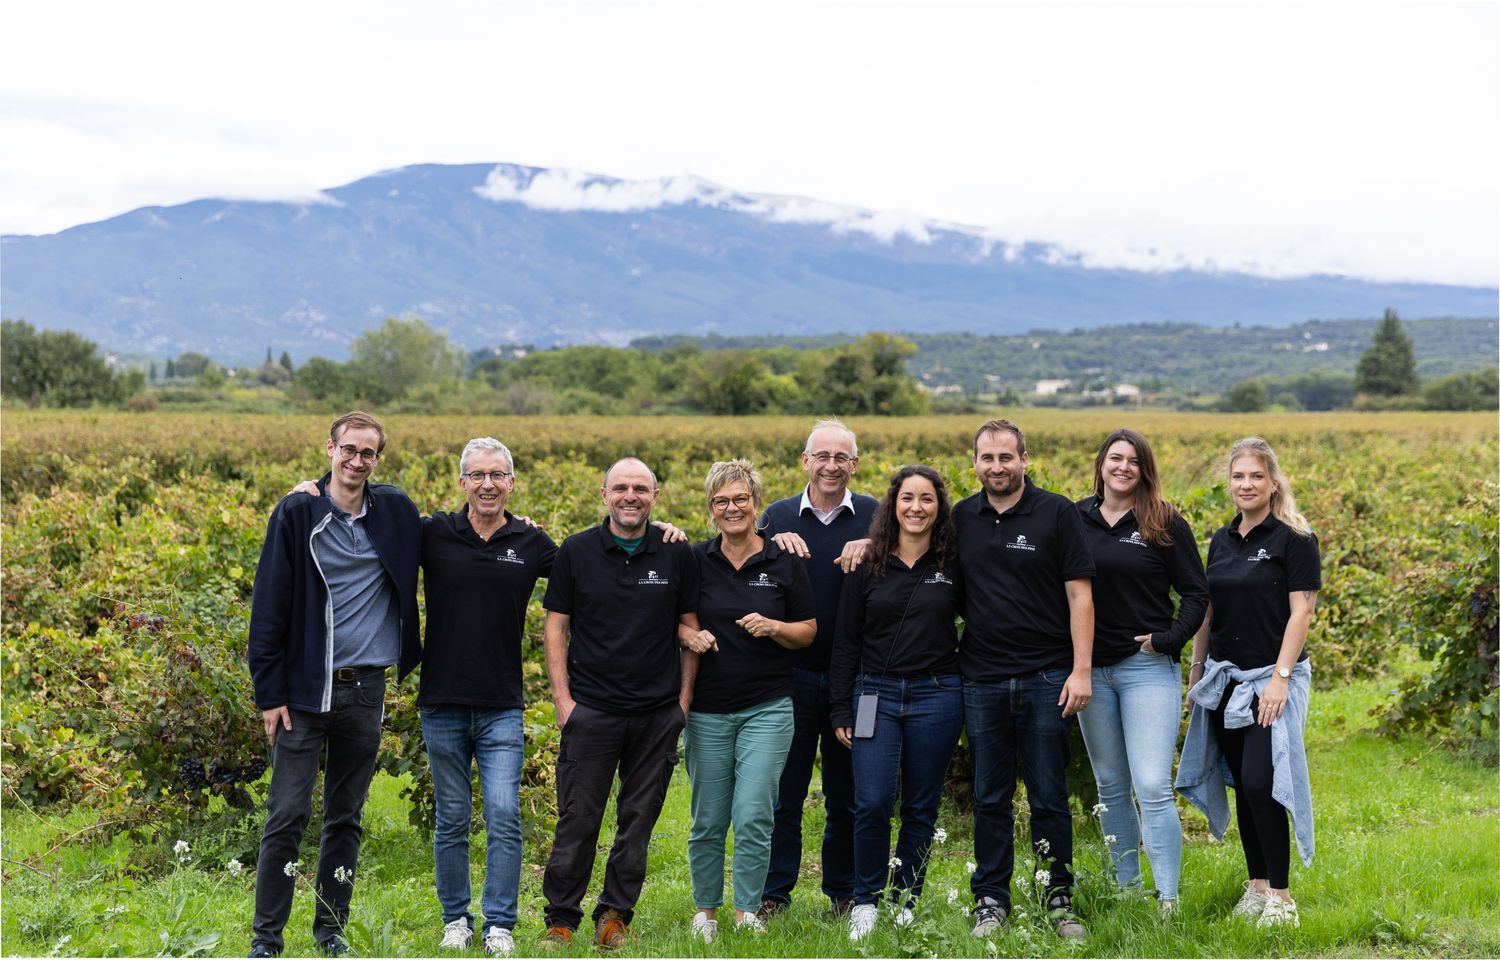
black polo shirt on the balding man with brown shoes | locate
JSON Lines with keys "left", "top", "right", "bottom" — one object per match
{"left": 542, "top": 519, "right": 699, "bottom": 714}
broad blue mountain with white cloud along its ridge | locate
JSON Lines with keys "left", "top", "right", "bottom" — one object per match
{"left": 0, "top": 164, "right": 1500, "bottom": 363}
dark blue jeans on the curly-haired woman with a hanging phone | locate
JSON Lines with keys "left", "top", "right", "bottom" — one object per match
{"left": 854, "top": 674, "right": 963, "bottom": 903}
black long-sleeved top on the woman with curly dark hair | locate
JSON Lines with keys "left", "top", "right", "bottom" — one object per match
{"left": 828, "top": 552, "right": 962, "bottom": 728}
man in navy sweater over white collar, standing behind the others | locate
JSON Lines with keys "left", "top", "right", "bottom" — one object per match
{"left": 761, "top": 420, "right": 876, "bottom": 917}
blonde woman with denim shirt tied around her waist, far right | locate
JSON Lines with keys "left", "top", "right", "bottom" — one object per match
{"left": 1178, "top": 437, "right": 1323, "bottom": 927}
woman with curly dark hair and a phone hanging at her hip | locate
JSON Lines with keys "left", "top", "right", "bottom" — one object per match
{"left": 828, "top": 465, "right": 963, "bottom": 941}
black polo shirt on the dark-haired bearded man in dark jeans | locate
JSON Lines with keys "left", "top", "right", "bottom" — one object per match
{"left": 953, "top": 477, "right": 1094, "bottom": 683}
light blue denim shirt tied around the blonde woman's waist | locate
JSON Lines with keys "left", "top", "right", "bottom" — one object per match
{"left": 1176, "top": 659, "right": 1313, "bottom": 866}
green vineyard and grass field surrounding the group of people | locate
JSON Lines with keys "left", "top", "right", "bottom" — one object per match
{"left": 0, "top": 411, "right": 1500, "bottom": 956}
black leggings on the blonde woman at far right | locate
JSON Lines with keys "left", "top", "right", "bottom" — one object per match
{"left": 1209, "top": 684, "right": 1292, "bottom": 890}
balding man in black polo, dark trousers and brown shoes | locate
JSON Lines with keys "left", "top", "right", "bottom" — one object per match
{"left": 542, "top": 458, "right": 699, "bottom": 950}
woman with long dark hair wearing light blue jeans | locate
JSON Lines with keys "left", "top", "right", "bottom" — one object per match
{"left": 1077, "top": 428, "right": 1209, "bottom": 912}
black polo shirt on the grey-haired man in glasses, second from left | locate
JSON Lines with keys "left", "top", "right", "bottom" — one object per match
{"left": 417, "top": 504, "right": 558, "bottom": 710}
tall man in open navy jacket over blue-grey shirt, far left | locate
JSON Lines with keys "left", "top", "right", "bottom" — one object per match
{"left": 249, "top": 411, "right": 422, "bottom": 957}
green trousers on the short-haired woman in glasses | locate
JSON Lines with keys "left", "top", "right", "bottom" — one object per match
{"left": 683, "top": 696, "right": 792, "bottom": 914}
